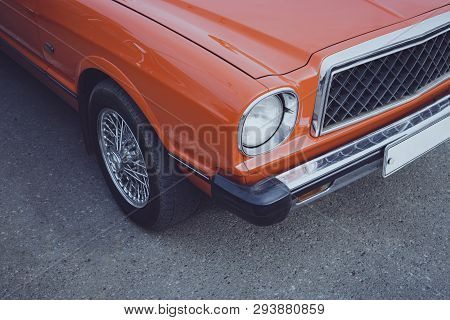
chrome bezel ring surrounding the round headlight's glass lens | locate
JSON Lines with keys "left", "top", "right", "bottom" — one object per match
{"left": 238, "top": 88, "right": 300, "bottom": 156}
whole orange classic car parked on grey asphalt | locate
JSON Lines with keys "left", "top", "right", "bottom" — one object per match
{"left": 0, "top": 0, "right": 450, "bottom": 229}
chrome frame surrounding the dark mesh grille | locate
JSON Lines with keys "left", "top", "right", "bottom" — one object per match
{"left": 312, "top": 12, "right": 450, "bottom": 137}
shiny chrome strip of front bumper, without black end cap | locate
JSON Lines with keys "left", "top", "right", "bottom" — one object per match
{"left": 276, "top": 95, "right": 450, "bottom": 191}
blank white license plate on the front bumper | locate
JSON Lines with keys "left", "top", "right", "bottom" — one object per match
{"left": 383, "top": 117, "right": 450, "bottom": 177}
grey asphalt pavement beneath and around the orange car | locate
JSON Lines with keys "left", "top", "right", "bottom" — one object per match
{"left": 0, "top": 54, "right": 450, "bottom": 299}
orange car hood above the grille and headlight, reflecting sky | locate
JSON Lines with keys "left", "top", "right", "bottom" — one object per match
{"left": 116, "top": 0, "right": 447, "bottom": 78}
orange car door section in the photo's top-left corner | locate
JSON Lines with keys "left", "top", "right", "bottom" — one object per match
{"left": 0, "top": 0, "right": 43, "bottom": 58}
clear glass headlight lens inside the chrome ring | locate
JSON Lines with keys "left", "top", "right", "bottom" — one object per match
{"left": 242, "top": 96, "right": 283, "bottom": 148}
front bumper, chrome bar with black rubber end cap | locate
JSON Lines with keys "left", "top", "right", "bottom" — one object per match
{"left": 212, "top": 95, "right": 450, "bottom": 226}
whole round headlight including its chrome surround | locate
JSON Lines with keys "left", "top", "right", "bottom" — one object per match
{"left": 238, "top": 88, "right": 298, "bottom": 156}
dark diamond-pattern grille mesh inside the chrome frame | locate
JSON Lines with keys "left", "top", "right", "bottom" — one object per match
{"left": 323, "top": 30, "right": 450, "bottom": 129}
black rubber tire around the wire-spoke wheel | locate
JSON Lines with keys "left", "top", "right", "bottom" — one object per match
{"left": 89, "top": 80, "right": 201, "bottom": 230}
